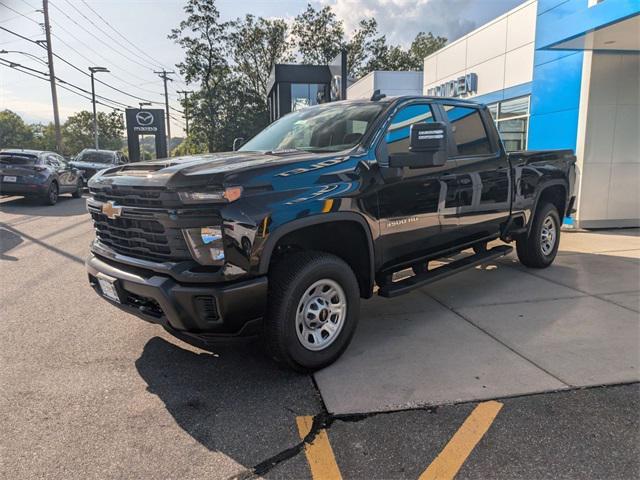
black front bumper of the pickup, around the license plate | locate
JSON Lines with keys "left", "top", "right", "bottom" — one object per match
{"left": 86, "top": 254, "right": 267, "bottom": 340}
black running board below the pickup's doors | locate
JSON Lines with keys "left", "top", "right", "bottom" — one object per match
{"left": 378, "top": 245, "right": 513, "bottom": 298}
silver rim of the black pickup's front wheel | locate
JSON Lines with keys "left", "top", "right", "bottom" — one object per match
{"left": 296, "top": 278, "right": 347, "bottom": 352}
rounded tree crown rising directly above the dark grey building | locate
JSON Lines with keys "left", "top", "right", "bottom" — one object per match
{"left": 291, "top": 3, "right": 344, "bottom": 65}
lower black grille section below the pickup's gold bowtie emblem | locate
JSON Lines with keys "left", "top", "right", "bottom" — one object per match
{"left": 89, "top": 209, "right": 191, "bottom": 262}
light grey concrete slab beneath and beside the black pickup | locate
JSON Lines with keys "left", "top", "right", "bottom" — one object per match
{"left": 315, "top": 230, "right": 640, "bottom": 413}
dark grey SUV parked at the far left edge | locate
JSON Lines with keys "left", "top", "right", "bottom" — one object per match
{"left": 0, "top": 149, "right": 82, "bottom": 205}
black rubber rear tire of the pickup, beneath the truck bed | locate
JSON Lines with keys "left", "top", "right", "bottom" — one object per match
{"left": 516, "top": 203, "right": 561, "bottom": 268}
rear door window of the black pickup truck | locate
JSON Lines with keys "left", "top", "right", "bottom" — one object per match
{"left": 444, "top": 105, "right": 492, "bottom": 155}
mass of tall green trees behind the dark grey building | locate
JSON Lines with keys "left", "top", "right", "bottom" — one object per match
{"left": 169, "top": 0, "right": 446, "bottom": 155}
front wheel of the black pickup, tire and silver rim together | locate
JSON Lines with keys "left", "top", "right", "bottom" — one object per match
{"left": 264, "top": 252, "right": 360, "bottom": 372}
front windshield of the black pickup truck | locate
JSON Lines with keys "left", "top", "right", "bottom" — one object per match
{"left": 240, "top": 103, "right": 385, "bottom": 152}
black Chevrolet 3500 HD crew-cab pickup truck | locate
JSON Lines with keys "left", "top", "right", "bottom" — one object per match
{"left": 87, "top": 96, "right": 575, "bottom": 371}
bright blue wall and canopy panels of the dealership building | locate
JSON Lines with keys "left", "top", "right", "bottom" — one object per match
{"left": 528, "top": 0, "right": 640, "bottom": 150}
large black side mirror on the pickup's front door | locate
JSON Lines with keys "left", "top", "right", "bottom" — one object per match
{"left": 389, "top": 122, "right": 447, "bottom": 168}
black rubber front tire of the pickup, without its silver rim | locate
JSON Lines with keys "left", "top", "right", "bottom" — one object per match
{"left": 264, "top": 252, "right": 360, "bottom": 372}
